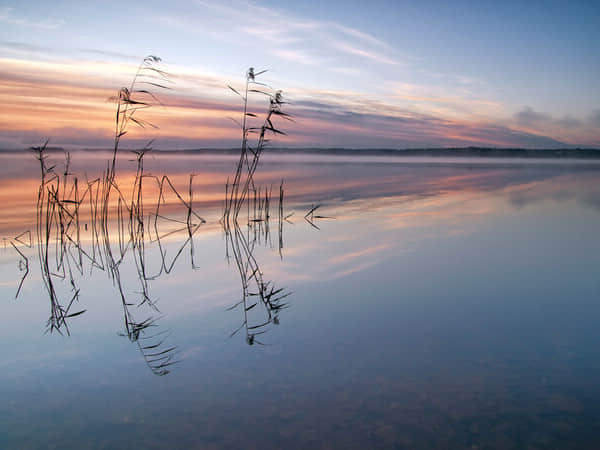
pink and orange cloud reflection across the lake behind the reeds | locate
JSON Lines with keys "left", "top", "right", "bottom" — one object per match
{"left": 0, "top": 154, "right": 600, "bottom": 298}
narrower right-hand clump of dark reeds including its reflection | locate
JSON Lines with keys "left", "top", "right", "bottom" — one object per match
{"left": 221, "top": 67, "right": 298, "bottom": 345}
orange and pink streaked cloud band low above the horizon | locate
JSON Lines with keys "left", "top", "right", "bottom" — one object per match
{"left": 0, "top": 47, "right": 597, "bottom": 148}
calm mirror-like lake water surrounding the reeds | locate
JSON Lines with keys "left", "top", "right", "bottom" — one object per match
{"left": 0, "top": 153, "right": 600, "bottom": 449}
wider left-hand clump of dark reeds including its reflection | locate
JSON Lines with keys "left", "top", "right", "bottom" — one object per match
{"left": 33, "top": 56, "right": 180, "bottom": 375}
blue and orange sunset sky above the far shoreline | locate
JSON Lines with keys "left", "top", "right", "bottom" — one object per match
{"left": 0, "top": 0, "right": 600, "bottom": 149}
